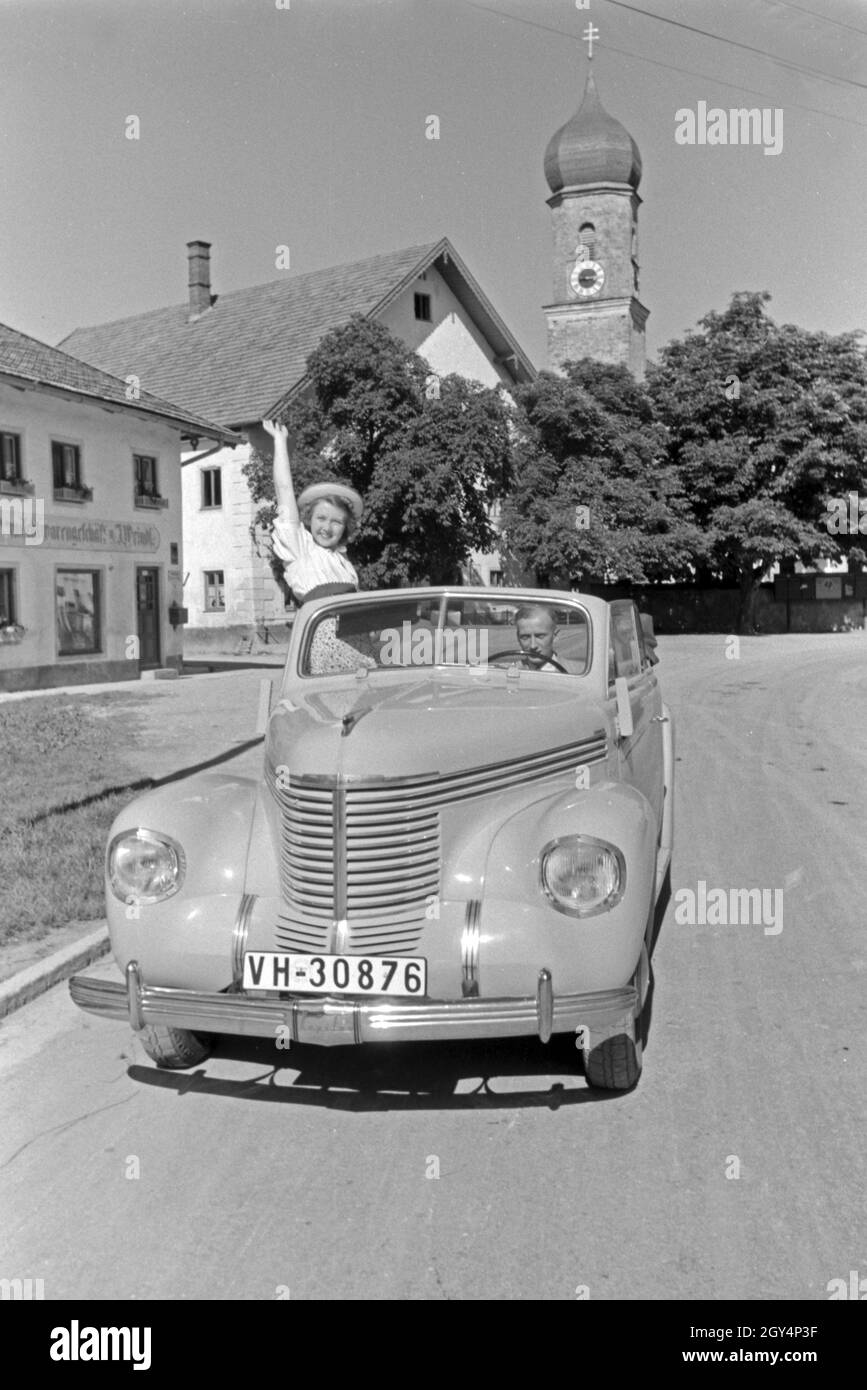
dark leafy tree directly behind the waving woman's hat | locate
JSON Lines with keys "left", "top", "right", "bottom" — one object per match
{"left": 245, "top": 314, "right": 513, "bottom": 588}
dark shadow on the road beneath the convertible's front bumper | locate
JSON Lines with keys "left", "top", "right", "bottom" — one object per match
{"left": 128, "top": 1034, "right": 629, "bottom": 1112}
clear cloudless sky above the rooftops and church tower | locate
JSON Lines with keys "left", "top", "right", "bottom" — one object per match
{"left": 0, "top": 0, "right": 867, "bottom": 367}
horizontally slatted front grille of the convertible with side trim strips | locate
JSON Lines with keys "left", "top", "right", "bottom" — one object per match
{"left": 265, "top": 733, "right": 607, "bottom": 955}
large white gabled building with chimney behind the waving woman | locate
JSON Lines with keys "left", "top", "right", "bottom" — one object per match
{"left": 63, "top": 239, "right": 535, "bottom": 649}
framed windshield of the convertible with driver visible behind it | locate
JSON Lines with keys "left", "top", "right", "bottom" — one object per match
{"left": 300, "top": 594, "right": 589, "bottom": 676}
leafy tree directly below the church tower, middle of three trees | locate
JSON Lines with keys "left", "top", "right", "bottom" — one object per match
{"left": 502, "top": 359, "right": 702, "bottom": 588}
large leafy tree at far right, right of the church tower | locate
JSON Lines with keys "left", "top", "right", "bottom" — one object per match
{"left": 647, "top": 292, "right": 867, "bottom": 631}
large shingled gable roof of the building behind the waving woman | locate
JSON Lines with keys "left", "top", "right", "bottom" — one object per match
{"left": 63, "top": 238, "right": 535, "bottom": 427}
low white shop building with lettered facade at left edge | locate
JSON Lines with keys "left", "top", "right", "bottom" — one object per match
{"left": 0, "top": 324, "right": 235, "bottom": 691}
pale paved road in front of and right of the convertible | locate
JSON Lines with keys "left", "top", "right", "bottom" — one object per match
{"left": 0, "top": 634, "right": 867, "bottom": 1300}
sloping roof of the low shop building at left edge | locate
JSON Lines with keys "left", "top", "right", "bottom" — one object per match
{"left": 0, "top": 324, "right": 236, "bottom": 443}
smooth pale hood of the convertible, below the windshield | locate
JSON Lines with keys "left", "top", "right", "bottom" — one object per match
{"left": 267, "top": 673, "right": 606, "bottom": 777}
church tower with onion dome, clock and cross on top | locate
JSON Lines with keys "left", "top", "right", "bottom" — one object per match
{"left": 545, "top": 68, "right": 649, "bottom": 379}
